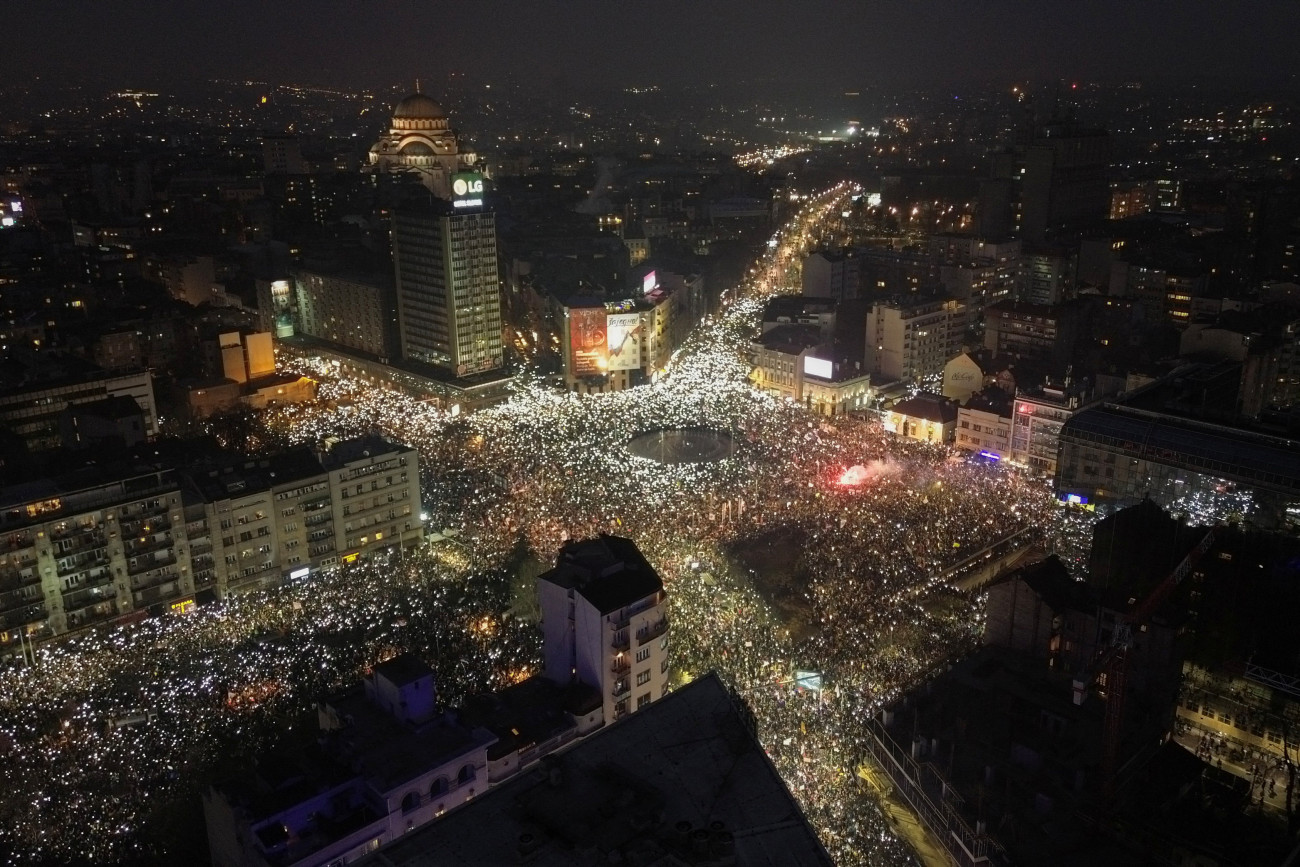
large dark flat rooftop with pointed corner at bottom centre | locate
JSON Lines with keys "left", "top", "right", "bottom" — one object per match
{"left": 358, "top": 673, "right": 832, "bottom": 867}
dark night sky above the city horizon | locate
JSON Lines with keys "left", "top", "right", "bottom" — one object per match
{"left": 0, "top": 0, "right": 1300, "bottom": 87}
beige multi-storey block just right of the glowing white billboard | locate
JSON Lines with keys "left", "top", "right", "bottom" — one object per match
{"left": 867, "top": 298, "right": 966, "bottom": 382}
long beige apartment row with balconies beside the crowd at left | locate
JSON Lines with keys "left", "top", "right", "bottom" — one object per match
{"left": 0, "top": 437, "right": 421, "bottom": 658}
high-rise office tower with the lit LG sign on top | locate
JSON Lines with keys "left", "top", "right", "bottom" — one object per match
{"left": 393, "top": 193, "right": 503, "bottom": 376}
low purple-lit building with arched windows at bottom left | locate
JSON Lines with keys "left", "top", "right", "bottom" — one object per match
{"left": 203, "top": 655, "right": 497, "bottom": 867}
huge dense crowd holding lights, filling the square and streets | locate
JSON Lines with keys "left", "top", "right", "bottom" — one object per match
{"left": 0, "top": 185, "right": 1091, "bottom": 864}
